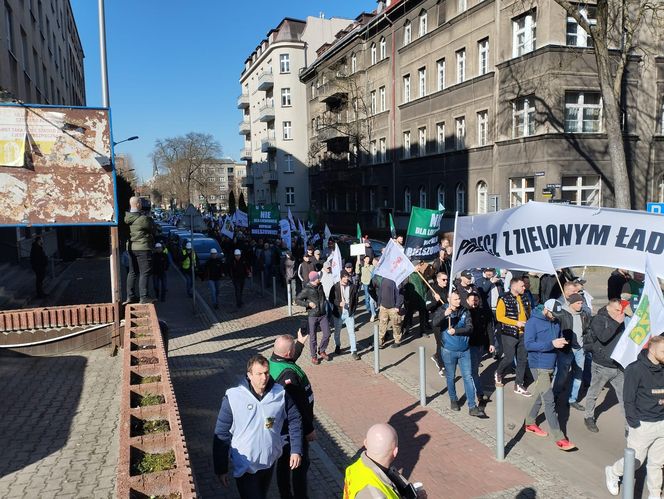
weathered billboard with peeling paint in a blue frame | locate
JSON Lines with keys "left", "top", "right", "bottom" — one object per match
{"left": 0, "top": 104, "right": 117, "bottom": 226}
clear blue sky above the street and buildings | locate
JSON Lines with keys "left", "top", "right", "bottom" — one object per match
{"left": 71, "top": 0, "right": 376, "bottom": 179}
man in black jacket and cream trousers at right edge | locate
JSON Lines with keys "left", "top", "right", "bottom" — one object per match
{"left": 604, "top": 336, "right": 664, "bottom": 497}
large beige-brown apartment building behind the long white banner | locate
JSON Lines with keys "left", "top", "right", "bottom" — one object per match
{"left": 300, "top": 0, "right": 664, "bottom": 231}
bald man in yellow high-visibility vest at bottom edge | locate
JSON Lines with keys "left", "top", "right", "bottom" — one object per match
{"left": 343, "top": 423, "right": 427, "bottom": 499}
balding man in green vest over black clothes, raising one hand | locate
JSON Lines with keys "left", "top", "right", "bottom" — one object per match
{"left": 270, "top": 329, "right": 316, "bottom": 499}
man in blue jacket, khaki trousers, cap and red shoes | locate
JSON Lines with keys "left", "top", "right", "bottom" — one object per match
{"left": 524, "top": 299, "right": 576, "bottom": 451}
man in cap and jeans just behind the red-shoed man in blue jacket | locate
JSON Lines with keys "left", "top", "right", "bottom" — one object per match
{"left": 553, "top": 292, "right": 591, "bottom": 411}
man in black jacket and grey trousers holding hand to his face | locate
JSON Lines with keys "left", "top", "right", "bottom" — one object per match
{"left": 583, "top": 299, "right": 625, "bottom": 433}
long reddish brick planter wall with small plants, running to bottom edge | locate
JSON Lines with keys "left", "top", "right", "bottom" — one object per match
{"left": 117, "top": 304, "right": 196, "bottom": 499}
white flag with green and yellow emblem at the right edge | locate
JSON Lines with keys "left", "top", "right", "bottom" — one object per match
{"left": 611, "top": 256, "right": 664, "bottom": 367}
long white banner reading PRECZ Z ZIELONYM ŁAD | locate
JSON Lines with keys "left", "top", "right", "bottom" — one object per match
{"left": 454, "top": 201, "right": 664, "bottom": 277}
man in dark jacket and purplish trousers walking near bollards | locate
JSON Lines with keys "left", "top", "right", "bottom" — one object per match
{"left": 295, "top": 270, "right": 330, "bottom": 365}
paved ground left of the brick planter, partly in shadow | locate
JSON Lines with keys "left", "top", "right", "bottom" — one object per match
{"left": 0, "top": 348, "right": 121, "bottom": 498}
